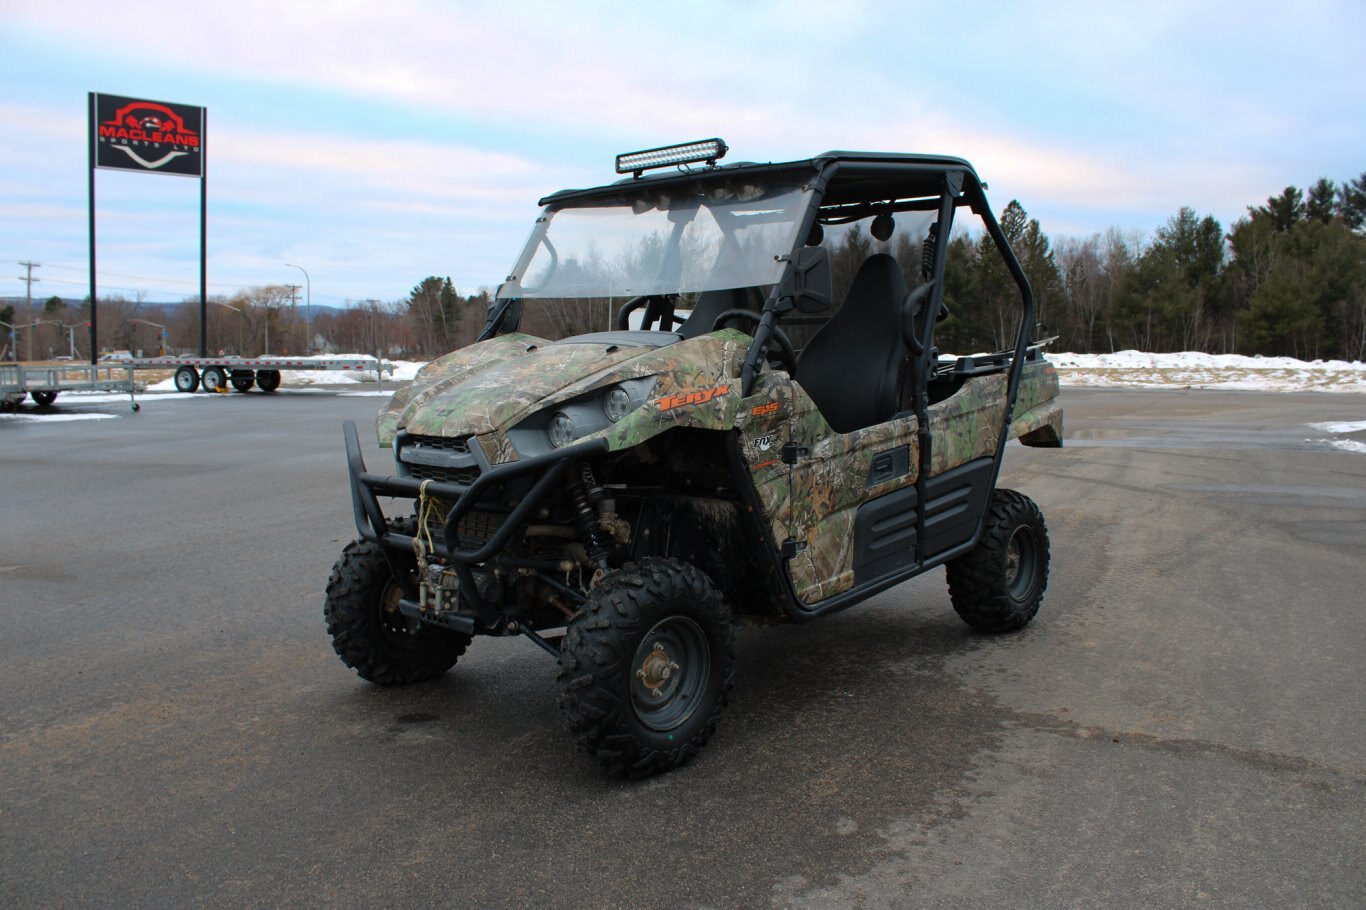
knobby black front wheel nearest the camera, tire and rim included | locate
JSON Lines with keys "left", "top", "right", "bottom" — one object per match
{"left": 556, "top": 557, "right": 735, "bottom": 777}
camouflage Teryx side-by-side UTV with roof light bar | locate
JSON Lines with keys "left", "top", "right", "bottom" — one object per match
{"left": 325, "top": 141, "right": 1063, "bottom": 776}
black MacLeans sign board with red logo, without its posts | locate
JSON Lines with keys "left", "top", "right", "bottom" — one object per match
{"left": 90, "top": 94, "right": 204, "bottom": 176}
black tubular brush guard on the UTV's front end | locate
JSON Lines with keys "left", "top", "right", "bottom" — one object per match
{"left": 342, "top": 421, "right": 608, "bottom": 568}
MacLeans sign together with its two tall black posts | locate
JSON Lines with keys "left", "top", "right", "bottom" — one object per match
{"left": 89, "top": 92, "right": 209, "bottom": 363}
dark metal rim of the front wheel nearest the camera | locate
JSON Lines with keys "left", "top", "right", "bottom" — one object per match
{"left": 630, "top": 616, "right": 712, "bottom": 731}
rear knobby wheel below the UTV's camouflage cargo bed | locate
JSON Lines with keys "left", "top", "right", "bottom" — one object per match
{"left": 947, "top": 489, "right": 1048, "bottom": 633}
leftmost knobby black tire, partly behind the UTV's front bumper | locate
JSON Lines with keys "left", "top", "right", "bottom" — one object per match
{"left": 322, "top": 521, "right": 470, "bottom": 686}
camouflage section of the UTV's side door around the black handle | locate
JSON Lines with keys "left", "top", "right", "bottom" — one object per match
{"left": 788, "top": 385, "right": 921, "bottom": 603}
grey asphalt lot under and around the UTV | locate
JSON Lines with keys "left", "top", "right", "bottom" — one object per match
{"left": 0, "top": 389, "right": 1366, "bottom": 909}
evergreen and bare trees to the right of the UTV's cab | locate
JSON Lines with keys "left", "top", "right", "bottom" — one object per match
{"left": 937, "top": 174, "right": 1366, "bottom": 361}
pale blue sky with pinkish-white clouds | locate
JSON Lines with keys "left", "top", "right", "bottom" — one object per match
{"left": 0, "top": 0, "right": 1366, "bottom": 305}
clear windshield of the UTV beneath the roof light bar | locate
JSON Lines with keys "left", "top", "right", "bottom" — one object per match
{"left": 500, "top": 176, "right": 810, "bottom": 299}
